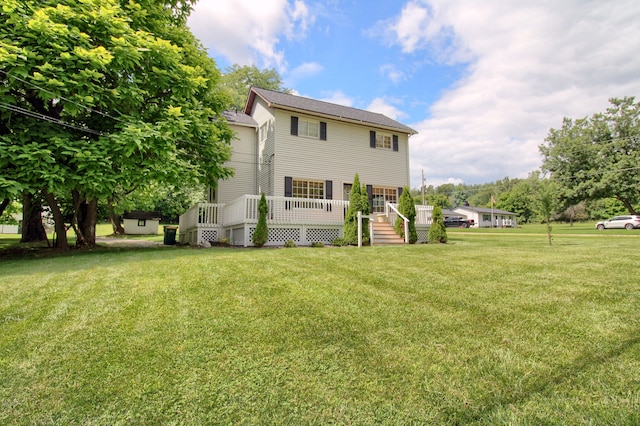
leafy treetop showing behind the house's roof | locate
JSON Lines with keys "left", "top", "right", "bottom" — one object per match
{"left": 221, "top": 64, "right": 291, "bottom": 110}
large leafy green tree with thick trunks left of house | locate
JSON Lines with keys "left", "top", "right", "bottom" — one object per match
{"left": 0, "top": 0, "right": 231, "bottom": 247}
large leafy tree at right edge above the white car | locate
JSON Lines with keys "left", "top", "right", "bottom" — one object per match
{"left": 540, "top": 97, "right": 640, "bottom": 214}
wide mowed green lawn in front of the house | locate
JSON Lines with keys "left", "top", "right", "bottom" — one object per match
{"left": 0, "top": 232, "right": 640, "bottom": 425}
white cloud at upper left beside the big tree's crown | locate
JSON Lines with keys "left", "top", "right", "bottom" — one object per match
{"left": 188, "top": 0, "right": 314, "bottom": 73}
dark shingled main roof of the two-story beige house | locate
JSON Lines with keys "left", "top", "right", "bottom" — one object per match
{"left": 244, "top": 87, "right": 418, "bottom": 135}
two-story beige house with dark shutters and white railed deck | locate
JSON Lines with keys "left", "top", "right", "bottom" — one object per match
{"left": 179, "top": 88, "right": 431, "bottom": 247}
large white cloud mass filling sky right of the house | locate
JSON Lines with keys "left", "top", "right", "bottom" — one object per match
{"left": 393, "top": 0, "right": 640, "bottom": 186}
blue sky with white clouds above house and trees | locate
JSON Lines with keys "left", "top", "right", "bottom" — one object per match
{"left": 189, "top": 0, "right": 640, "bottom": 188}
